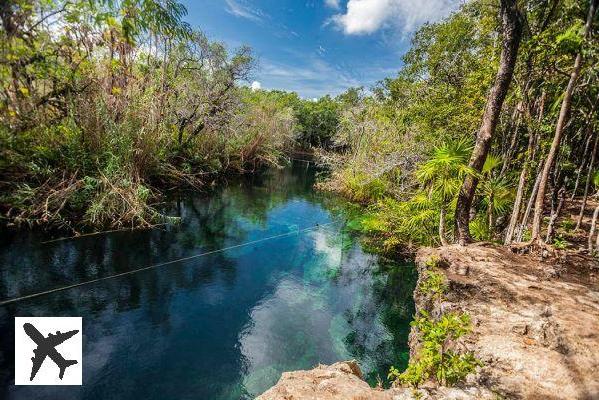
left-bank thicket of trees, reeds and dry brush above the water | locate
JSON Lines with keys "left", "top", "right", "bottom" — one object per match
{"left": 0, "top": 0, "right": 310, "bottom": 229}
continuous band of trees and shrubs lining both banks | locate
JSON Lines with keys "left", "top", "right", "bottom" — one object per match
{"left": 0, "top": 0, "right": 599, "bottom": 251}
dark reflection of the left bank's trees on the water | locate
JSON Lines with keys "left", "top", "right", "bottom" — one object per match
{"left": 0, "top": 160, "right": 332, "bottom": 396}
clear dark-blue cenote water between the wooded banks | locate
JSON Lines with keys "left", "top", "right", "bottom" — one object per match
{"left": 0, "top": 162, "right": 415, "bottom": 399}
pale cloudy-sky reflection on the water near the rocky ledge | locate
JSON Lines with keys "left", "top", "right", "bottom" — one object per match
{"left": 239, "top": 225, "right": 410, "bottom": 395}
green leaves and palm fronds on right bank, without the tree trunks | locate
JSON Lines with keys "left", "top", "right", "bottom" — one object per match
{"left": 321, "top": 0, "right": 599, "bottom": 250}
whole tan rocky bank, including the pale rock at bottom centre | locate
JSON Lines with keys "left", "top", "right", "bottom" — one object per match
{"left": 259, "top": 244, "right": 599, "bottom": 400}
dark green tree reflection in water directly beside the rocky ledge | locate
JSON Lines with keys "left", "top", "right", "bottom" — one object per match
{"left": 332, "top": 241, "right": 416, "bottom": 384}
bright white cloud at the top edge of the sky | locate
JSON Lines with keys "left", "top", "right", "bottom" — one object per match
{"left": 332, "top": 0, "right": 462, "bottom": 35}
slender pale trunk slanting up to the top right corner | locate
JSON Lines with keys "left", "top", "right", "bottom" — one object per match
{"left": 532, "top": 0, "right": 599, "bottom": 241}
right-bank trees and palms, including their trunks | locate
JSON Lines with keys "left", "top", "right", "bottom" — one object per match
{"left": 324, "top": 0, "right": 599, "bottom": 255}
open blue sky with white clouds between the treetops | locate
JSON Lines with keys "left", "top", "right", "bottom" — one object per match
{"left": 180, "top": 0, "right": 463, "bottom": 98}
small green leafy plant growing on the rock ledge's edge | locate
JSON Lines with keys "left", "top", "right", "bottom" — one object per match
{"left": 389, "top": 312, "right": 481, "bottom": 387}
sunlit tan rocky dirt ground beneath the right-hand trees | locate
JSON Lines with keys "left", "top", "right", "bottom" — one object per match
{"left": 418, "top": 244, "right": 599, "bottom": 400}
